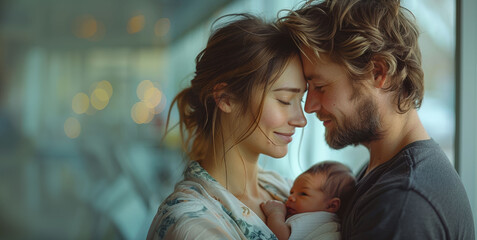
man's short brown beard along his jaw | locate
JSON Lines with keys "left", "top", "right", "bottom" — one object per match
{"left": 325, "top": 97, "right": 382, "bottom": 149}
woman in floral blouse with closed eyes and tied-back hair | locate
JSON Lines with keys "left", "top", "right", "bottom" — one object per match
{"left": 147, "top": 15, "right": 306, "bottom": 239}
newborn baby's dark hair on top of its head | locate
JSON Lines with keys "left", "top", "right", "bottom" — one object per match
{"left": 303, "top": 161, "right": 356, "bottom": 216}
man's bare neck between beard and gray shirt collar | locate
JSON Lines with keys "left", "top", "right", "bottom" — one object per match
{"left": 364, "top": 109, "right": 430, "bottom": 174}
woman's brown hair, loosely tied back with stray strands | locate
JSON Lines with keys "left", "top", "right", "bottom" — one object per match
{"left": 166, "top": 14, "right": 299, "bottom": 160}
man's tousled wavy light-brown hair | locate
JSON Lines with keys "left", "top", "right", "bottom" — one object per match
{"left": 277, "top": 0, "right": 424, "bottom": 113}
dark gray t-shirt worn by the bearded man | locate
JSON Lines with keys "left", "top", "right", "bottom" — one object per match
{"left": 341, "top": 139, "right": 475, "bottom": 240}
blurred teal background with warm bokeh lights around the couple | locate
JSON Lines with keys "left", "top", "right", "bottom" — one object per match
{"left": 0, "top": 0, "right": 477, "bottom": 239}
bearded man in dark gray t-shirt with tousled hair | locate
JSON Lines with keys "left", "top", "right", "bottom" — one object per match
{"left": 278, "top": 0, "right": 474, "bottom": 239}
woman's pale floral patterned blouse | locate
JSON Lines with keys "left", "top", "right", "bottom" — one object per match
{"left": 147, "top": 161, "right": 292, "bottom": 239}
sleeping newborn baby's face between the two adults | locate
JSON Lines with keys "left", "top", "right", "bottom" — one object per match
{"left": 286, "top": 173, "right": 330, "bottom": 217}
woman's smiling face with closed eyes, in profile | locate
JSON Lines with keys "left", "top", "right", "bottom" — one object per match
{"left": 241, "top": 56, "right": 306, "bottom": 158}
